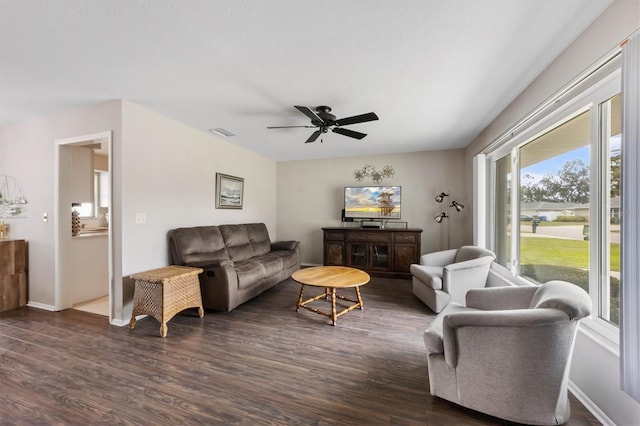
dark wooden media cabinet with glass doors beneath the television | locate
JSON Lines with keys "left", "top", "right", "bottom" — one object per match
{"left": 322, "top": 228, "right": 422, "bottom": 278}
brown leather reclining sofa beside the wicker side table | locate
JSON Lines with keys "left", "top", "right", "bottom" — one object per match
{"left": 169, "top": 223, "right": 300, "bottom": 311}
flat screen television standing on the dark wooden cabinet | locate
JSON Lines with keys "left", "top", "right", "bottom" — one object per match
{"left": 344, "top": 186, "right": 402, "bottom": 219}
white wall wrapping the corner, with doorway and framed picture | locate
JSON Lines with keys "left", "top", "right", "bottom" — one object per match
{"left": 0, "top": 101, "right": 277, "bottom": 323}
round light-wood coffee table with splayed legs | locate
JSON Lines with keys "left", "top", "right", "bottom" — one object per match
{"left": 291, "top": 266, "right": 370, "bottom": 325}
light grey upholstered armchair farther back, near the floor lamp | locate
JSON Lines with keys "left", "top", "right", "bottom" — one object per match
{"left": 410, "top": 246, "right": 496, "bottom": 313}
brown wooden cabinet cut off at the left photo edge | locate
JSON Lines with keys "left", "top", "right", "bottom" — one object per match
{"left": 0, "top": 240, "right": 27, "bottom": 312}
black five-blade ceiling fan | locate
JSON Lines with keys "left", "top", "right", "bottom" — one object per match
{"left": 267, "top": 105, "right": 378, "bottom": 143}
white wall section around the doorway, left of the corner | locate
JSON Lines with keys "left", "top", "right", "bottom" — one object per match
{"left": 0, "top": 101, "right": 120, "bottom": 308}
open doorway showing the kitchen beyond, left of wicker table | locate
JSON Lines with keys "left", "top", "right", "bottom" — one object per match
{"left": 54, "top": 131, "right": 114, "bottom": 323}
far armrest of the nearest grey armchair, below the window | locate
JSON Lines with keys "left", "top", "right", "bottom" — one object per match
{"left": 466, "top": 286, "right": 538, "bottom": 311}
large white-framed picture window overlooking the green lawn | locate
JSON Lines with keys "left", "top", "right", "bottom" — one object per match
{"left": 487, "top": 72, "right": 621, "bottom": 326}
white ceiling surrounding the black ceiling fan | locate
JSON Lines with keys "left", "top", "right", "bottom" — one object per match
{"left": 0, "top": 0, "right": 612, "bottom": 161}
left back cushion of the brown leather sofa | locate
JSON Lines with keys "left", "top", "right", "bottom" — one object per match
{"left": 169, "top": 226, "right": 229, "bottom": 265}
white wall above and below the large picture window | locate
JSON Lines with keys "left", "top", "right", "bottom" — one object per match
{"left": 465, "top": 0, "right": 640, "bottom": 425}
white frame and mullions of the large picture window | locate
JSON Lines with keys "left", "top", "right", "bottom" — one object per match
{"left": 477, "top": 65, "right": 621, "bottom": 346}
